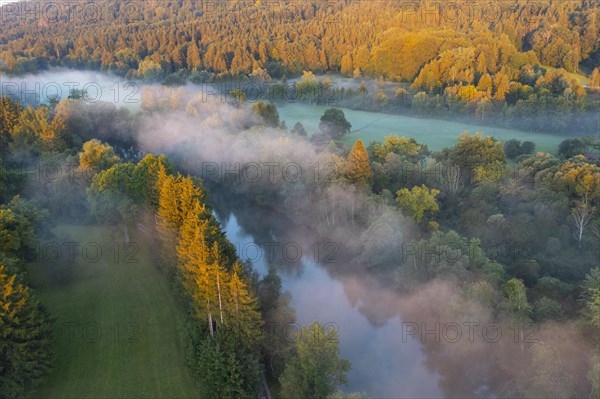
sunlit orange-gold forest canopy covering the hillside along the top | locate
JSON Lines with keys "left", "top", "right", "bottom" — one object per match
{"left": 0, "top": 0, "right": 600, "bottom": 81}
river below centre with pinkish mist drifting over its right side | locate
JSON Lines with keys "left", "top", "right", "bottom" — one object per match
{"left": 209, "top": 192, "right": 511, "bottom": 398}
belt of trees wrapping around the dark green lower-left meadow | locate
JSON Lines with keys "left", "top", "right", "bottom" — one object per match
{"left": 0, "top": 93, "right": 358, "bottom": 398}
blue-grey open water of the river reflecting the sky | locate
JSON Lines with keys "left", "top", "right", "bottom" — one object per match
{"left": 211, "top": 190, "right": 444, "bottom": 398}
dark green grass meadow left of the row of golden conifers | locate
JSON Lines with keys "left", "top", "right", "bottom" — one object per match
{"left": 29, "top": 225, "right": 198, "bottom": 399}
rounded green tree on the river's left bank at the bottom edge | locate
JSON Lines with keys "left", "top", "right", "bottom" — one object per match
{"left": 279, "top": 322, "right": 351, "bottom": 399}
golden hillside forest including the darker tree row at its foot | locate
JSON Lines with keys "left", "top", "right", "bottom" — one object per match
{"left": 0, "top": 0, "right": 600, "bottom": 134}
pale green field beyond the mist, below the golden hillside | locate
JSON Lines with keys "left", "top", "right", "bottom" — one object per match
{"left": 278, "top": 103, "right": 566, "bottom": 153}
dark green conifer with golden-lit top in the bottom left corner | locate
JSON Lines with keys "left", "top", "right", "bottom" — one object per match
{"left": 0, "top": 263, "right": 53, "bottom": 398}
